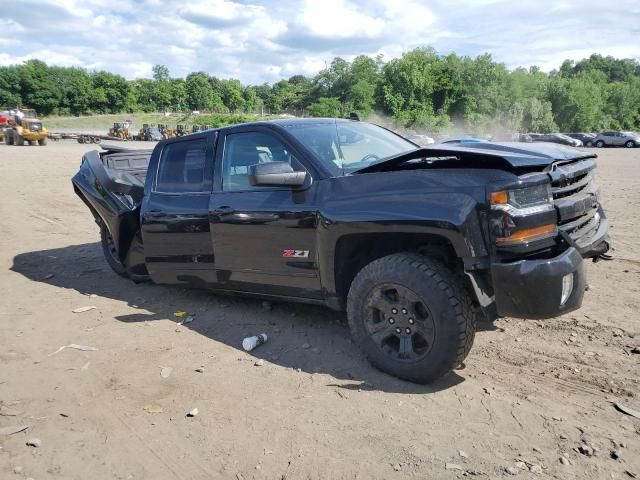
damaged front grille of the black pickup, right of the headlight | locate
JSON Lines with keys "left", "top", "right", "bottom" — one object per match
{"left": 549, "top": 158, "right": 601, "bottom": 246}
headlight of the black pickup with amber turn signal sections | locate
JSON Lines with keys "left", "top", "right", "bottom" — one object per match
{"left": 490, "top": 183, "right": 558, "bottom": 246}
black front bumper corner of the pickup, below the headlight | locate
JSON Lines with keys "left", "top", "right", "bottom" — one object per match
{"left": 491, "top": 247, "right": 586, "bottom": 318}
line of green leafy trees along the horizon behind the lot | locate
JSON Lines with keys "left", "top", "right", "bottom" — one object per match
{"left": 0, "top": 48, "right": 640, "bottom": 132}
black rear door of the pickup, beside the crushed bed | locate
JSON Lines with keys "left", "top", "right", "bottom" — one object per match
{"left": 141, "top": 132, "right": 216, "bottom": 286}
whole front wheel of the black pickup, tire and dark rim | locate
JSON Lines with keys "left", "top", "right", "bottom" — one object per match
{"left": 347, "top": 253, "right": 475, "bottom": 383}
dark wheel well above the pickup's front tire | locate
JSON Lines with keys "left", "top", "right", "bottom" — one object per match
{"left": 334, "top": 233, "right": 462, "bottom": 302}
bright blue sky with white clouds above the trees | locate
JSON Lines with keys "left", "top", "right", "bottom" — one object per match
{"left": 0, "top": 0, "right": 640, "bottom": 84}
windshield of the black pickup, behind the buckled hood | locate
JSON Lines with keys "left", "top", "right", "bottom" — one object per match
{"left": 287, "top": 121, "right": 418, "bottom": 175}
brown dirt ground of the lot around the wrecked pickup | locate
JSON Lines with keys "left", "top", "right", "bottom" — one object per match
{"left": 0, "top": 142, "right": 640, "bottom": 480}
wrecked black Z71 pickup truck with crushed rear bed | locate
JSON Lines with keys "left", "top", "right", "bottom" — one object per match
{"left": 73, "top": 119, "right": 609, "bottom": 382}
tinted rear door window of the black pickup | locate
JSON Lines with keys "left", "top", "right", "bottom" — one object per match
{"left": 155, "top": 139, "right": 211, "bottom": 193}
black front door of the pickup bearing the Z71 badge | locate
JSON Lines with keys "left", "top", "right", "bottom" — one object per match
{"left": 210, "top": 127, "right": 320, "bottom": 298}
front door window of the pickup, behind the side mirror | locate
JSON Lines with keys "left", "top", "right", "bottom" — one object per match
{"left": 222, "top": 132, "right": 305, "bottom": 192}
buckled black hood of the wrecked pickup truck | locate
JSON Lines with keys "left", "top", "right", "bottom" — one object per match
{"left": 353, "top": 142, "right": 596, "bottom": 174}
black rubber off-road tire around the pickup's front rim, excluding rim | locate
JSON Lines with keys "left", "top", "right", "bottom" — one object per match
{"left": 347, "top": 253, "right": 476, "bottom": 383}
